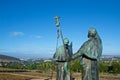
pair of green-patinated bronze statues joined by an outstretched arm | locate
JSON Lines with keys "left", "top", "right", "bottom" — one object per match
{"left": 53, "top": 16, "right": 102, "bottom": 80}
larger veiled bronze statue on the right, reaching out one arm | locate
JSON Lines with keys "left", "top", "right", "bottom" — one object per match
{"left": 72, "top": 28, "right": 102, "bottom": 80}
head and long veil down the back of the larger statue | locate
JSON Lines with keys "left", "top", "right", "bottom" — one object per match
{"left": 88, "top": 28, "right": 102, "bottom": 59}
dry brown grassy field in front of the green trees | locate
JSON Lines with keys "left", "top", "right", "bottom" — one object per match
{"left": 0, "top": 68, "right": 120, "bottom": 80}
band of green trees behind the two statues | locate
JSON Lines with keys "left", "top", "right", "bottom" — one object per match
{"left": 0, "top": 59, "right": 120, "bottom": 73}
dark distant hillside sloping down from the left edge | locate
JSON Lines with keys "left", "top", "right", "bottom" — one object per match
{"left": 0, "top": 54, "right": 20, "bottom": 62}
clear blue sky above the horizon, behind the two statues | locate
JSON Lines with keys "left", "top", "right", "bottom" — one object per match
{"left": 0, "top": 0, "right": 120, "bottom": 57}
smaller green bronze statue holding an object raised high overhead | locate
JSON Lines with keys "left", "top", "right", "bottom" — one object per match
{"left": 53, "top": 16, "right": 72, "bottom": 80}
